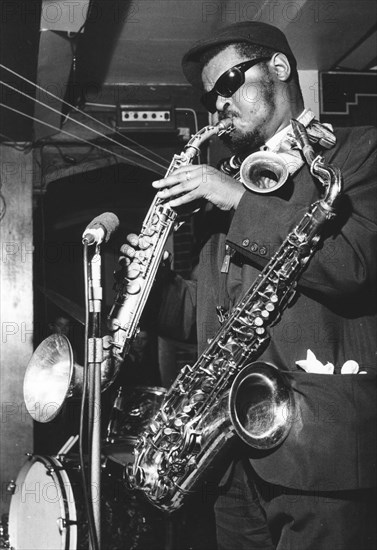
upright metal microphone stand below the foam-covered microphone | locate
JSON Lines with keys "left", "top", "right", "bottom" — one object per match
{"left": 88, "top": 245, "right": 103, "bottom": 550}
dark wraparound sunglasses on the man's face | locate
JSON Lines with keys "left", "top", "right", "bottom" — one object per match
{"left": 201, "top": 57, "right": 271, "bottom": 113}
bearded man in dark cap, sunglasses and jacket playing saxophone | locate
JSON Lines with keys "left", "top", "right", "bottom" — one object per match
{"left": 119, "top": 22, "right": 377, "bottom": 550}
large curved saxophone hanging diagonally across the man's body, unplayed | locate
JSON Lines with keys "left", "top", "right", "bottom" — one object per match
{"left": 124, "top": 120, "right": 341, "bottom": 512}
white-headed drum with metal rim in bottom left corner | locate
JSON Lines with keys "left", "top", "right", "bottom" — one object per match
{"left": 9, "top": 455, "right": 82, "bottom": 550}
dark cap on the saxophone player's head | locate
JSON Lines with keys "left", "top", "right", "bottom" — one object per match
{"left": 182, "top": 21, "right": 296, "bottom": 88}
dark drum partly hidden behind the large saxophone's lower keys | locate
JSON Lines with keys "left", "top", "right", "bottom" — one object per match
{"left": 106, "top": 386, "right": 166, "bottom": 443}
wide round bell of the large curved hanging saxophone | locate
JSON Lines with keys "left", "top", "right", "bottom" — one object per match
{"left": 229, "top": 361, "right": 296, "bottom": 450}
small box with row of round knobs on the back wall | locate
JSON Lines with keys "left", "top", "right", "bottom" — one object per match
{"left": 117, "top": 103, "right": 176, "bottom": 132}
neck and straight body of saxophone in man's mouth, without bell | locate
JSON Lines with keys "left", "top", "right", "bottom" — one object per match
{"left": 108, "top": 119, "right": 232, "bottom": 359}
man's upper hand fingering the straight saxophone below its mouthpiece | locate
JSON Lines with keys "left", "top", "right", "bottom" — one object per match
{"left": 152, "top": 164, "right": 245, "bottom": 210}
